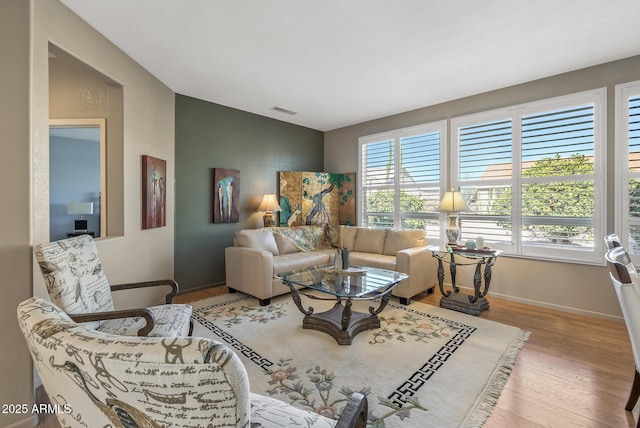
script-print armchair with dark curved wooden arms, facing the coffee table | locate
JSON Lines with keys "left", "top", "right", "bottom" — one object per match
{"left": 34, "top": 235, "right": 193, "bottom": 337}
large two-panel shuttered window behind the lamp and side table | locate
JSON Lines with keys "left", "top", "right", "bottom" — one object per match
{"left": 452, "top": 89, "right": 604, "bottom": 263}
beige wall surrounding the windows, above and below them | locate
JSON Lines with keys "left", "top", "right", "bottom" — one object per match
{"left": 324, "top": 56, "right": 640, "bottom": 319}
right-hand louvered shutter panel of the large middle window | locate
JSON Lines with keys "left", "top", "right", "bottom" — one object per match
{"left": 521, "top": 104, "right": 595, "bottom": 248}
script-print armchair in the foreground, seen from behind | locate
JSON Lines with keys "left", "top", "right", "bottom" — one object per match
{"left": 18, "top": 298, "right": 367, "bottom": 428}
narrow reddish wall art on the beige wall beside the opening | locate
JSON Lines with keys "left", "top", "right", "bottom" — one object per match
{"left": 142, "top": 155, "right": 167, "bottom": 229}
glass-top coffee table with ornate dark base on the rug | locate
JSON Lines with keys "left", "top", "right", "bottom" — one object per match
{"left": 277, "top": 265, "right": 409, "bottom": 345}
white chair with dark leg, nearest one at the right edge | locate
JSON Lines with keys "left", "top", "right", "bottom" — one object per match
{"left": 606, "top": 247, "right": 640, "bottom": 427}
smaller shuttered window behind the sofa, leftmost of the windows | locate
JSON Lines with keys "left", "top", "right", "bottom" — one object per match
{"left": 358, "top": 121, "right": 446, "bottom": 236}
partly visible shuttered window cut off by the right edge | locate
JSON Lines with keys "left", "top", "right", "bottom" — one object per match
{"left": 614, "top": 81, "right": 640, "bottom": 264}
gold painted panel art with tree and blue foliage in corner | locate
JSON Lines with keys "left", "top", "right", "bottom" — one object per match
{"left": 279, "top": 171, "right": 356, "bottom": 226}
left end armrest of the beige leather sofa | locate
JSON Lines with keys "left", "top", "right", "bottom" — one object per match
{"left": 224, "top": 247, "right": 273, "bottom": 299}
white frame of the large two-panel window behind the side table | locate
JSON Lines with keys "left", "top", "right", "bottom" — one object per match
{"left": 450, "top": 88, "right": 607, "bottom": 265}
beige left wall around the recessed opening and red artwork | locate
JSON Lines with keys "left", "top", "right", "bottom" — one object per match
{"left": 32, "top": 0, "right": 175, "bottom": 304}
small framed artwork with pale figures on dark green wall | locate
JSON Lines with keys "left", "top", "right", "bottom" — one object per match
{"left": 213, "top": 168, "right": 240, "bottom": 223}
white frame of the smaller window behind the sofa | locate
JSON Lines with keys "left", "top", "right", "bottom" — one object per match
{"left": 356, "top": 120, "right": 448, "bottom": 237}
